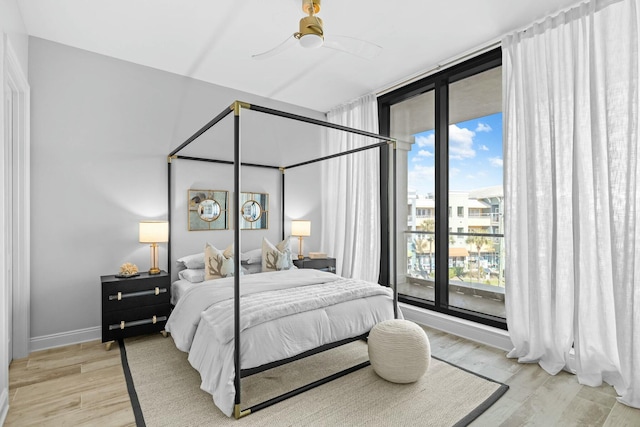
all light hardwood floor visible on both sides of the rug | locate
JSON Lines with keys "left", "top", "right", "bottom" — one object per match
{"left": 5, "top": 328, "right": 640, "bottom": 427}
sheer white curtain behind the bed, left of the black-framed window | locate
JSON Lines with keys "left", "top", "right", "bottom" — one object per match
{"left": 322, "top": 94, "right": 380, "bottom": 282}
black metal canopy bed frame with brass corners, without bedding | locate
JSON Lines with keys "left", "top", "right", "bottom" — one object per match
{"left": 167, "top": 101, "right": 398, "bottom": 419}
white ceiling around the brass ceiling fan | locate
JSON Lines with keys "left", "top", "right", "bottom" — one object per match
{"left": 18, "top": 0, "right": 576, "bottom": 112}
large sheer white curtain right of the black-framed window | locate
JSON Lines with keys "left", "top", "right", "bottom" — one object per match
{"left": 503, "top": 0, "right": 640, "bottom": 407}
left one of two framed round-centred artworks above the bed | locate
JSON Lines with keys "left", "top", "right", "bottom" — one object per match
{"left": 188, "top": 190, "right": 229, "bottom": 231}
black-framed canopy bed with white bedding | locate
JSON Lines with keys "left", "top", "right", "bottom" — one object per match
{"left": 162, "top": 101, "right": 402, "bottom": 418}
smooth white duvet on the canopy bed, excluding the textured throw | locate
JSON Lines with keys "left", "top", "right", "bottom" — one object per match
{"left": 166, "top": 269, "right": 400, "bottom": 416}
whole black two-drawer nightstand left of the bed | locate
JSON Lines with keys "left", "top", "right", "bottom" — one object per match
{"left": 100, "top": 271, "right": 171, "bottom": 350}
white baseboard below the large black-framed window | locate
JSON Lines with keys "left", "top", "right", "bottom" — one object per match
{"left": 399, "top": 303, "right": 513, "bottom": 351}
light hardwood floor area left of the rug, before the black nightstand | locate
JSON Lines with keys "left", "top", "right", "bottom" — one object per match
{"left": 5, "top": 341, "right": 136, "bottom": 427}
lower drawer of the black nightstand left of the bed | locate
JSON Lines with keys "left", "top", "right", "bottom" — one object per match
{"left": 102, "top": 304, "right": 171, "bottom": 342}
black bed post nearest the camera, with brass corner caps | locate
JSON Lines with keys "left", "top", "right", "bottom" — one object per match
{"left": 231, "top": 101, "right": 251, "bottom": 419}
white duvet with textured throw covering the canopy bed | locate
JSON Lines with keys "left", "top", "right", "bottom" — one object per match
{"left": 166, "top": 269, "right": 400, "bottom": 416}
